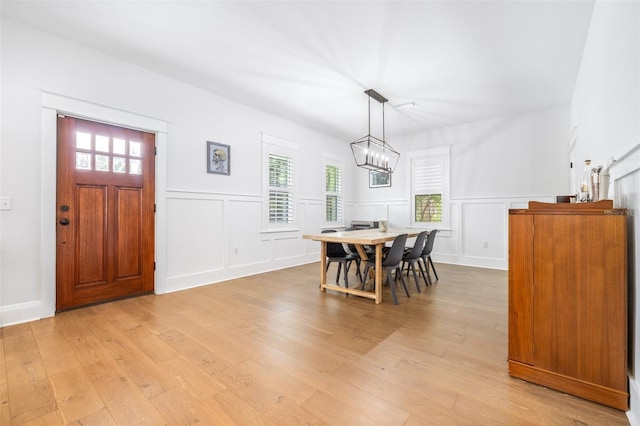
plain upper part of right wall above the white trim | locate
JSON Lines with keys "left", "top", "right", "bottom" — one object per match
{"left": 571, "top": 1, "right": 640, "bottom": 170}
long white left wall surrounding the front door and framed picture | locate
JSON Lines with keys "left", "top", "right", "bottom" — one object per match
{"left": 0, "top": 20, "right": 351, "bottom": 326}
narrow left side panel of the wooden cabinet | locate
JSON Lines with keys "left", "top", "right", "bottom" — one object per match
{"left": 509, "top": 214, "right": 533, "bottom": 364}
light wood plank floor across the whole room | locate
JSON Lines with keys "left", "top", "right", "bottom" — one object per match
{"left": 0, "top": 264, "right": 628, "bottom": 426}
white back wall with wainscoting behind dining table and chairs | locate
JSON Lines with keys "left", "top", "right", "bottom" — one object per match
{"left": 351, "top": 106, "right": 570, "bottom": 269}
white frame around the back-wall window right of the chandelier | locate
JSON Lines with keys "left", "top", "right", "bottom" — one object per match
{"left": 409, "top": 146, "right": 451, "bottom": 230}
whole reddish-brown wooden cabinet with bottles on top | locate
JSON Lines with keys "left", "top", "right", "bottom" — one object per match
{"left": 509, "top": 200, "right": 629, "bottom": 410}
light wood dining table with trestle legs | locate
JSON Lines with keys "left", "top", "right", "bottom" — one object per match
{"left": 302, "top": 228, "right": 424, "bottom": 304}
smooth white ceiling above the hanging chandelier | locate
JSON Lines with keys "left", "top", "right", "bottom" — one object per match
{"left": 1, "top": 0, "right": 593, "bottom": 141}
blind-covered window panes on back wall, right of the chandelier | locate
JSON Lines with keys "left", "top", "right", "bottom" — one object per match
{"left": 412, "top": 155, "right": 446, "bottom": 224}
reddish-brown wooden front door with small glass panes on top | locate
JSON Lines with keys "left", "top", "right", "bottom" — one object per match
{"left": 56, "top": 116, "right": 155, "bottom": 310}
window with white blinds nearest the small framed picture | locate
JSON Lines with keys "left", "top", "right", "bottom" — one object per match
{"left": 269, "top": 153, "right": 294, "bottom": 223}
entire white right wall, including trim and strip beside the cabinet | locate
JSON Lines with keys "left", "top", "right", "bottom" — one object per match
{"left": 572, "top": 1, "right": 640, "bottom": 425}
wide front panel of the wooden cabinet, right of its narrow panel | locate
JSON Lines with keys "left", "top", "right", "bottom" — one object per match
{"left": 533, "top": 214, "right": 627, "bottom": 389}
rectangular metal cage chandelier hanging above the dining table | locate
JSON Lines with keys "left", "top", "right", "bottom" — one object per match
{"left": 351, "top": 89, "right": 400, "bottom": 173}
